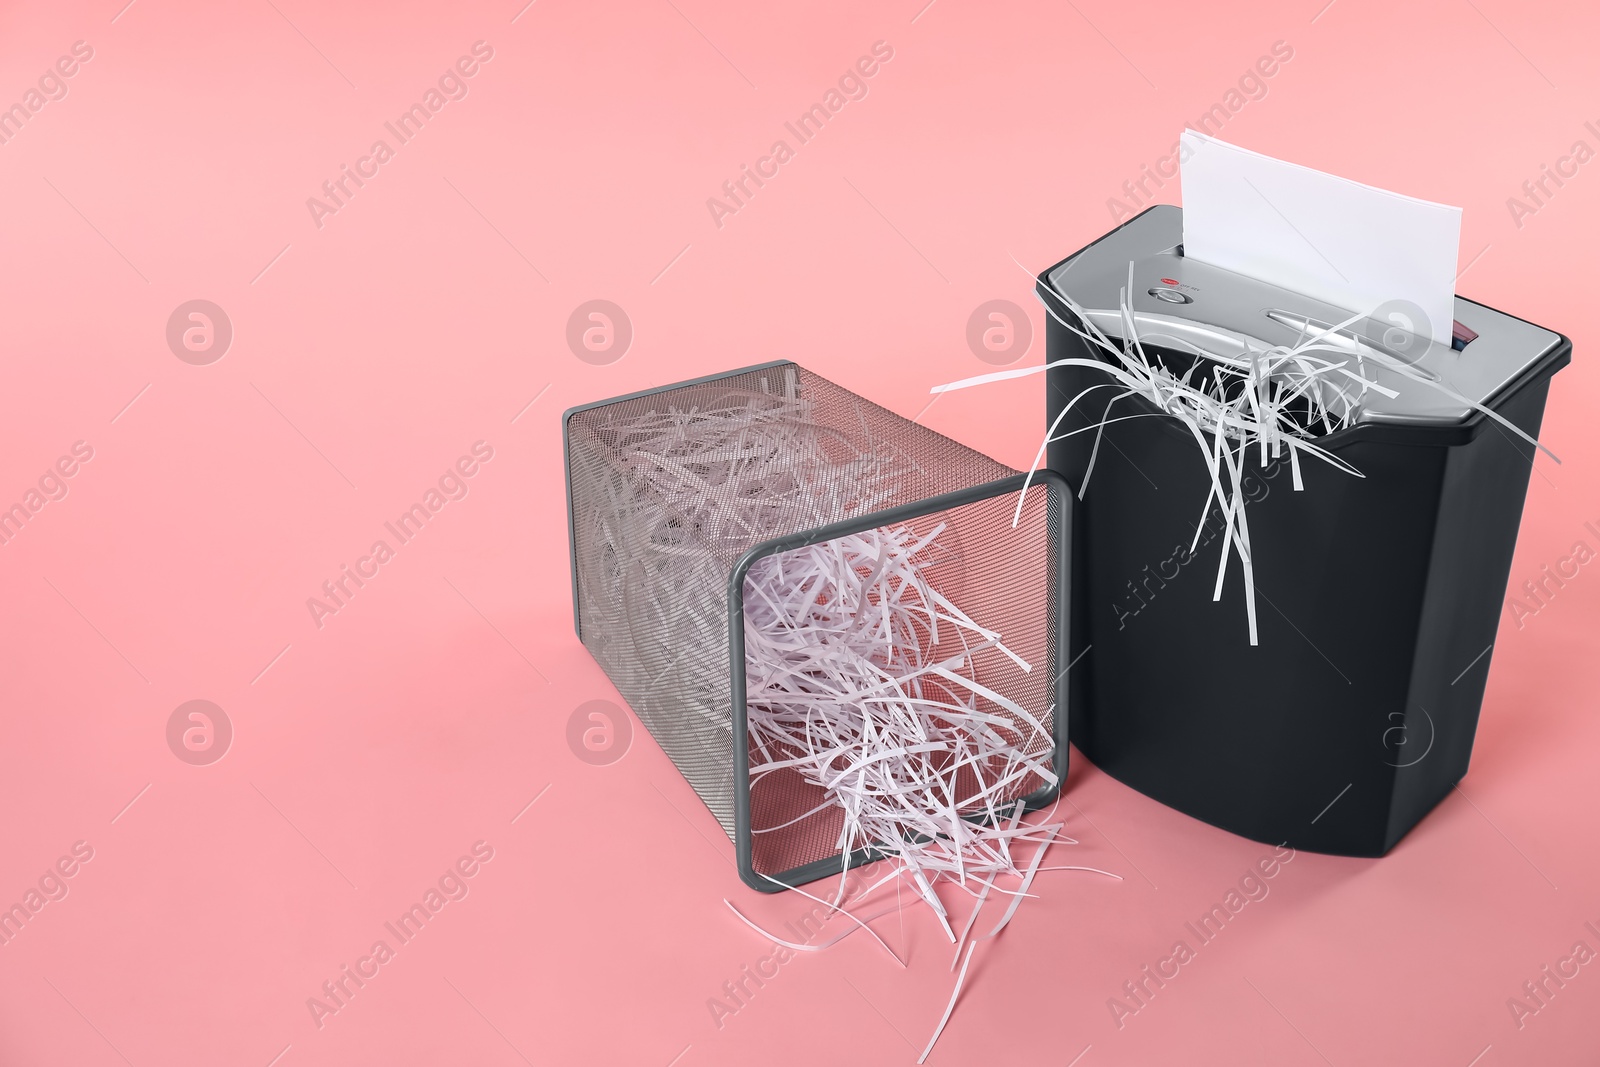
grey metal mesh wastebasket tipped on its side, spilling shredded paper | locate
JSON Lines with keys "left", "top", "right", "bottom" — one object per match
{"left": 565, "top": 362, "right": 1069, "bottom": 891}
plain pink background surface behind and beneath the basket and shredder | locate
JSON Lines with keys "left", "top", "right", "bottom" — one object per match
{"left": 0, "top": 0, "right": 1600, "bottom": 1067}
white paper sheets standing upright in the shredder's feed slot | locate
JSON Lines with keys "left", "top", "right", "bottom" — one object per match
{"left": 1179, "top": 130, "right": 1461, "bottom": 344}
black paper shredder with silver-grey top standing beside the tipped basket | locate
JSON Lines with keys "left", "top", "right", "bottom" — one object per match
{"left": 1037, "top": 206, "right": 1571, "bottom": 856}
